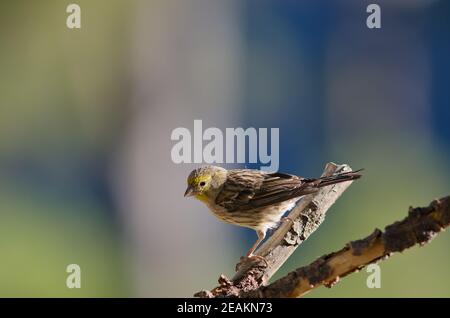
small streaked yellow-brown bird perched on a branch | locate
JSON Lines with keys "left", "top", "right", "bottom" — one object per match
{"left": 184, "top": 165, "right": 362, "bottom": 258}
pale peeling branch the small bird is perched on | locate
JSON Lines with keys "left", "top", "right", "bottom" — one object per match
{"left": 194, "top": 163, "right": 352, "bottom": 298}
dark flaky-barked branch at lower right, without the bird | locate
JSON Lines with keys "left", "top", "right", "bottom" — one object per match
{"left": 244, "top": 196, "right": 450, "bottom": 298}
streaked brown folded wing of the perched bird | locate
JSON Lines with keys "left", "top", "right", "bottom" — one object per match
{"left": 216, "top": 170, "right": 310, "bottom": 212}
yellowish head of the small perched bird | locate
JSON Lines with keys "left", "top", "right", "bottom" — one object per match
{"left": 184, "top": 166, "right": 227, "bottom": 202}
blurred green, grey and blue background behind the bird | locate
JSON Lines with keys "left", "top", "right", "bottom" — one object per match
{"left": 0, "top": 0, "right": 450, "bottom": 297}
